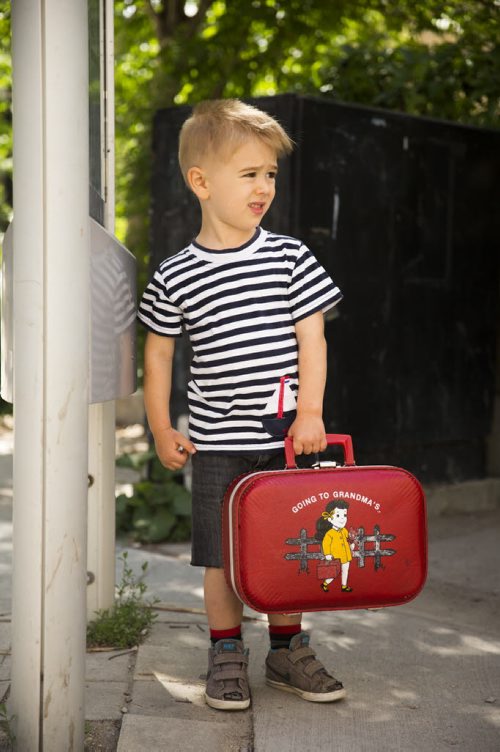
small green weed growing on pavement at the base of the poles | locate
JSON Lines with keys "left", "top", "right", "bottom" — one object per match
{"left": 87, "top": 551, "right": 157, "bottom": 648}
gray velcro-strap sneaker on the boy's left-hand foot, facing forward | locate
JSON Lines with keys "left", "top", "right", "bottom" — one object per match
{"left": 205, "top": 639, "right": 250, "bottom": 710}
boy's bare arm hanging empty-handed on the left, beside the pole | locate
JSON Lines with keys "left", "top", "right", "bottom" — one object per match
{"left": 144, "top": 332, "right": 196, "bottom": 470}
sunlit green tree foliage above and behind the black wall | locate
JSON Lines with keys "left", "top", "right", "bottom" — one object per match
{"left": 0, "top": 0, "right": 500, "bottom": 274}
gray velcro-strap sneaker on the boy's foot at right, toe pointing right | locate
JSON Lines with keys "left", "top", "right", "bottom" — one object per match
{"left": 266, "top": 632, "right": 346, "bottom": 702}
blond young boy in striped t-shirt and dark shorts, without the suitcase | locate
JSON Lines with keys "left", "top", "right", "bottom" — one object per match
{"left": 139, "top": 99, "right": 345, "bottom": 710}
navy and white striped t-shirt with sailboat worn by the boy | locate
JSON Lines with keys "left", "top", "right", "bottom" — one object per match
{"left": 139, "top": 228, "right": 342, "bottom": 453}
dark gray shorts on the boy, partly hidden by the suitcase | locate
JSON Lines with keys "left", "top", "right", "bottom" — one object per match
{"left": 191, "top": 449, "right": 317, "bottom": 568}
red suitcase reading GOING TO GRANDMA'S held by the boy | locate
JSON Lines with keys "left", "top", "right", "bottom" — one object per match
{"left": 223, "top": 434, "right": 427, "bottom": 613}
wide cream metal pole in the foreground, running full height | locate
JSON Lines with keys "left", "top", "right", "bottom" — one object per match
{"left": 11, "top": 0, "right": 89, "bottom": 752}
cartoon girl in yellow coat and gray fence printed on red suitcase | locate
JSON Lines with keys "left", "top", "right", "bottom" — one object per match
{"left": 284, "top": 493, "right": 396, "bottom": 593}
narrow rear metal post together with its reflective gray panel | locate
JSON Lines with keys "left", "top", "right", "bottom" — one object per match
{"left": 87, "top": 0, "right": 137, "bottom": 618}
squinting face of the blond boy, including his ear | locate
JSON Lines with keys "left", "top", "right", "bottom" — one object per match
{"left": 194, "top": 139, "right": 278, "bottom": 244}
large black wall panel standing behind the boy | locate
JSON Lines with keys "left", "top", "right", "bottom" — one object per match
{"left": 152, "top": 95, "right": 500, "bottom": 481}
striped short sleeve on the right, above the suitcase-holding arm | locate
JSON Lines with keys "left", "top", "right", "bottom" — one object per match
{"left": 288, "top": 245, "right": 342, "bottom": 323}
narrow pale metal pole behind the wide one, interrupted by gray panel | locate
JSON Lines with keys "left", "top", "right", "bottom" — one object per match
{"left": 87, "top": 0, "right": 115, "bottom": 619}
